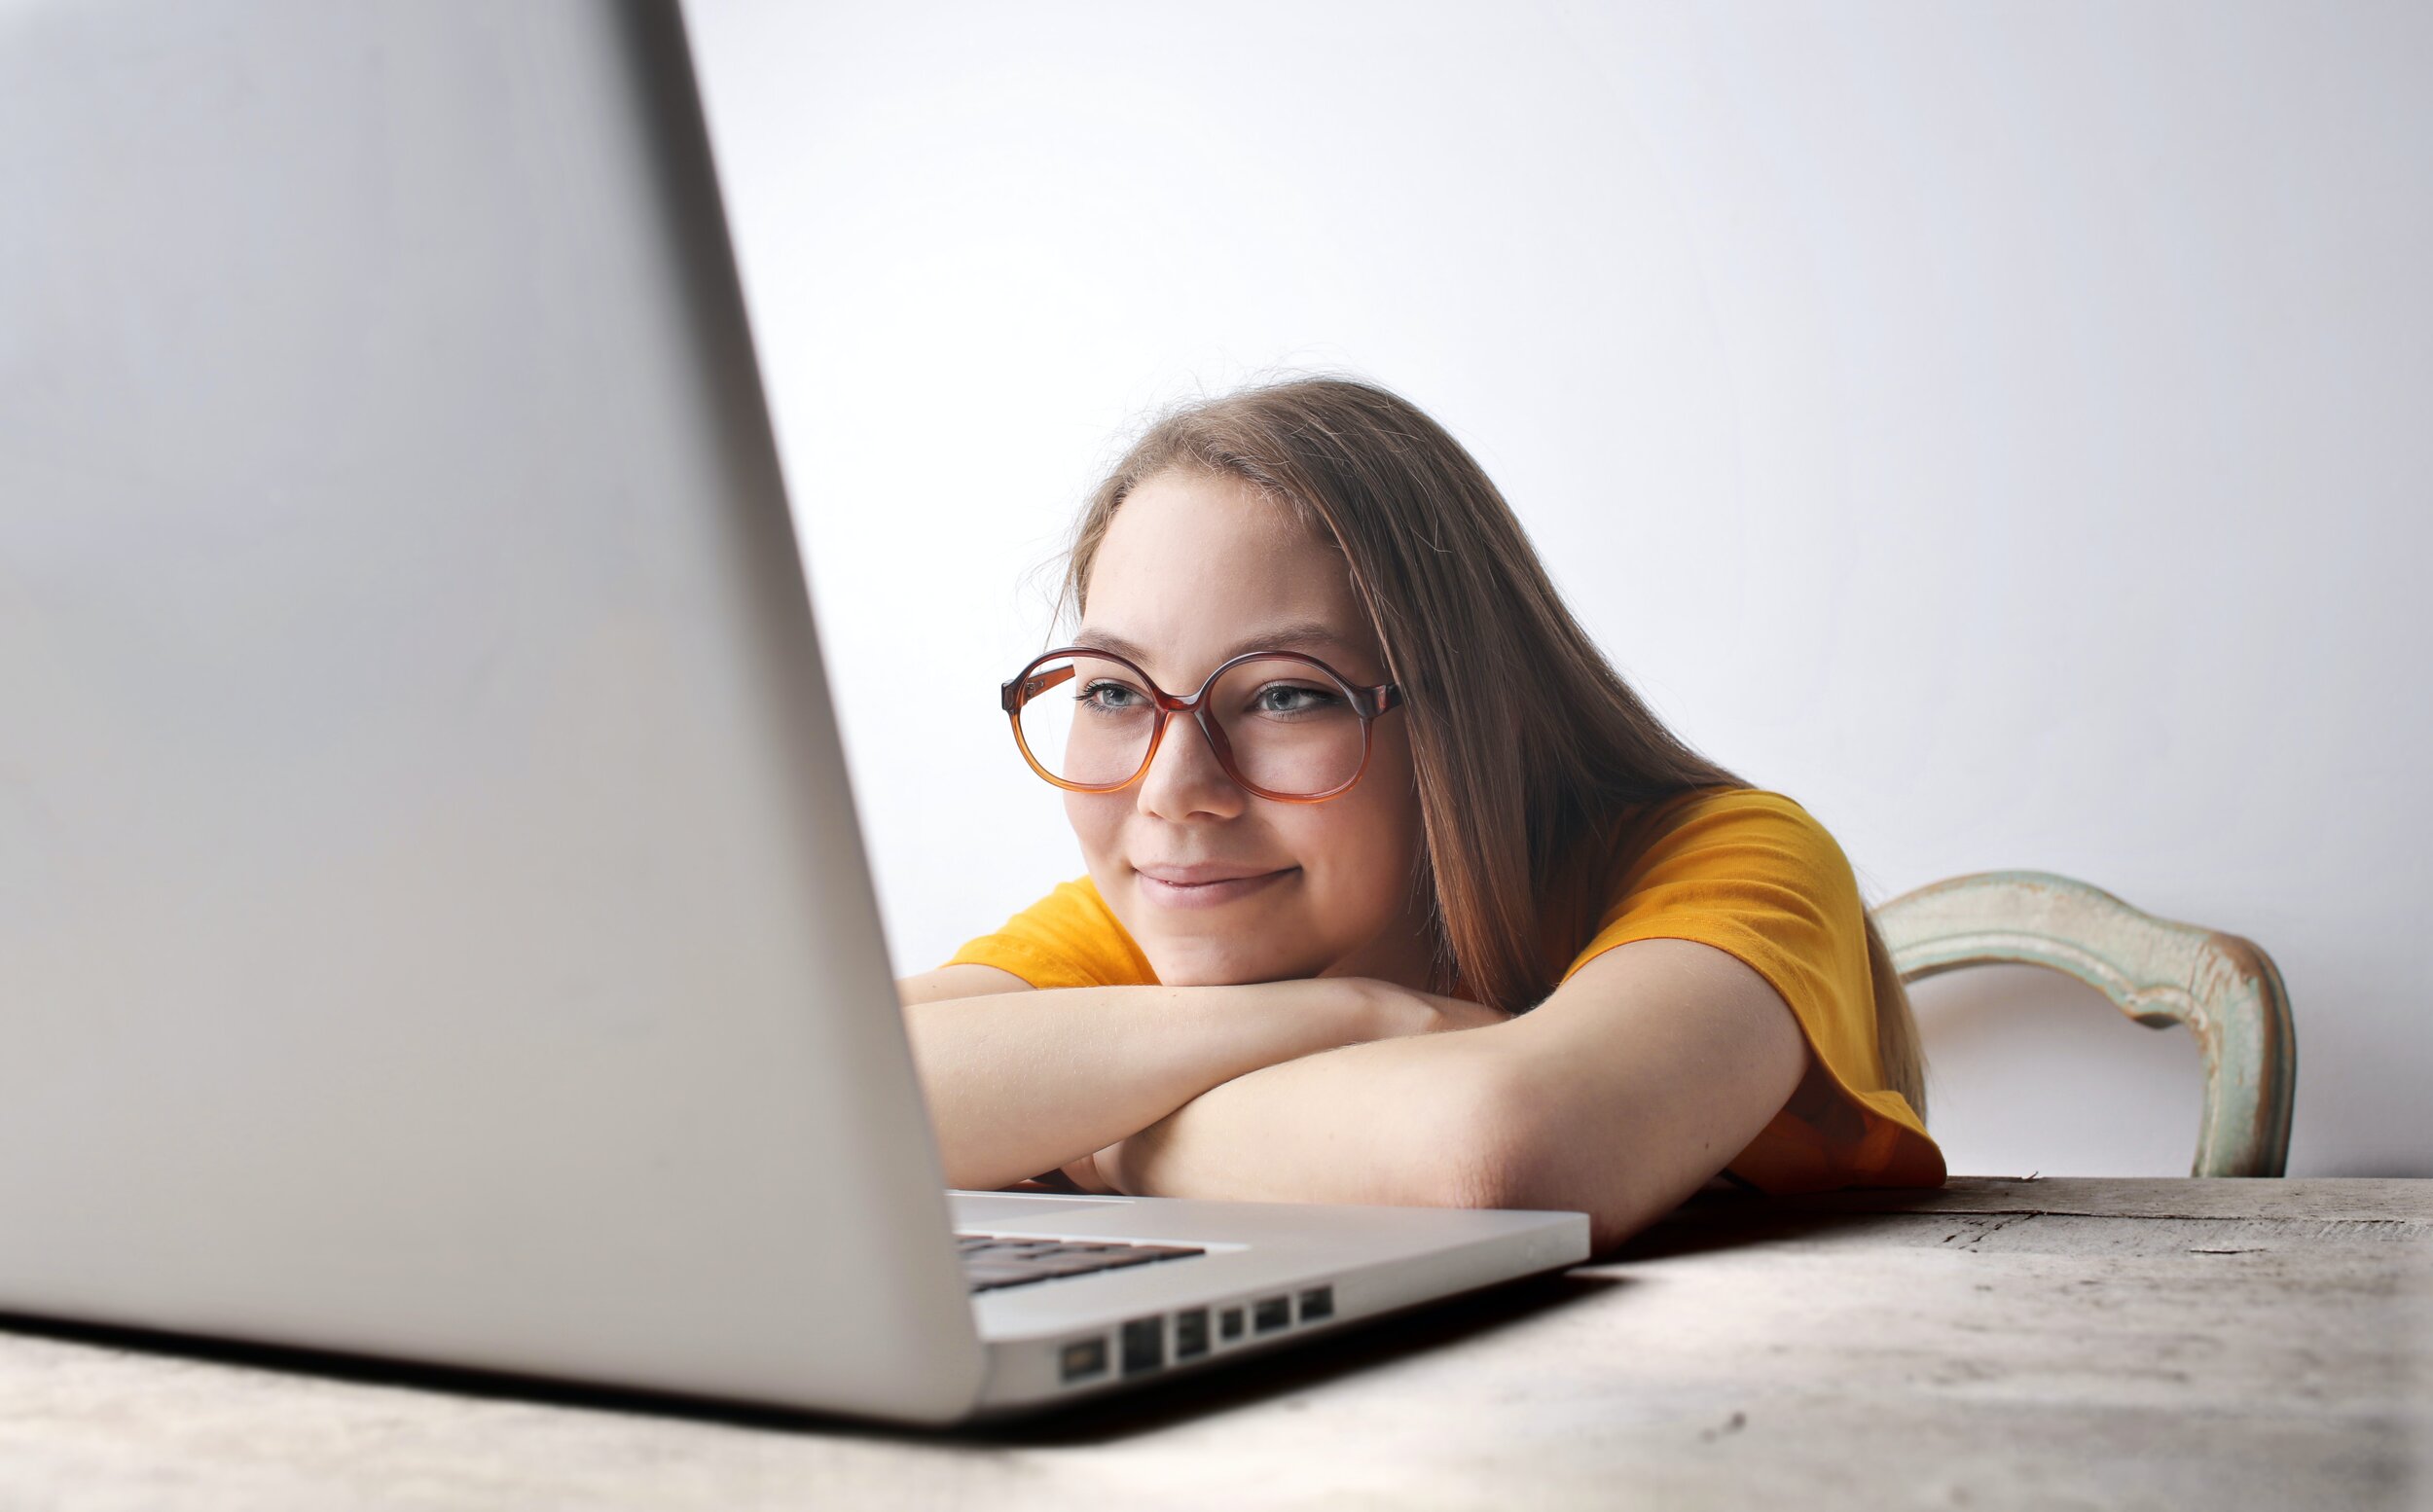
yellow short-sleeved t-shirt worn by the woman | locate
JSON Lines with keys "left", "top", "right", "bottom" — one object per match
{"left": 949, "top": 787, "right": 1944, "bottom": 1194}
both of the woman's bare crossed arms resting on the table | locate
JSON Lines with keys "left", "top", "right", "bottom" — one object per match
{"left": 900, "top": 938, "right": 1810, "bottom": 1249}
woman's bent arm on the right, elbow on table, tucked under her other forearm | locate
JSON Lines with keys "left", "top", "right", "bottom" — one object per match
{"left": 1085, "top": 938, "right": 1808, "bottom": 1249}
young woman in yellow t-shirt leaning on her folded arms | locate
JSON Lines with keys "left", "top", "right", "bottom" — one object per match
{"left": 903, "top": 379, "right": 1944, "bottom": 1249}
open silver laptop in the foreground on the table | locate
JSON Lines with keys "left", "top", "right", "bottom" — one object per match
{"left": 0, "top": 0, "right": 1589, "bottom": 1422}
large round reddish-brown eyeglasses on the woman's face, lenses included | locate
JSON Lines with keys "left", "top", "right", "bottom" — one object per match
{"left": 1000, "top": 647, "right": 1401, "bottom": 802}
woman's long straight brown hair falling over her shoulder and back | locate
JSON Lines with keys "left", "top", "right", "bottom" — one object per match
{"left": 1064, "top": 377, "right": 1927, "bottom": 1118}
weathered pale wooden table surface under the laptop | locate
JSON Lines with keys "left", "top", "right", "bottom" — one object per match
{"left": 0, "top": 1179, "right": 2433, "bottom": 1512}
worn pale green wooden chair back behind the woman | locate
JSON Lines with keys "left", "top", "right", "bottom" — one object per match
{"left": 1873, "top": 873, "right": 2297, "bottom": 1176}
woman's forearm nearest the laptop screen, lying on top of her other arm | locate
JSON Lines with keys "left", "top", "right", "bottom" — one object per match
{"left": 898, "top": 965, "right": 1487, "bottom": 1189}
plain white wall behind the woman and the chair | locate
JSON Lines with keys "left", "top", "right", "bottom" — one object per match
{"left": 691, "top": 0, "right": 2433, "bottom": 1174}
